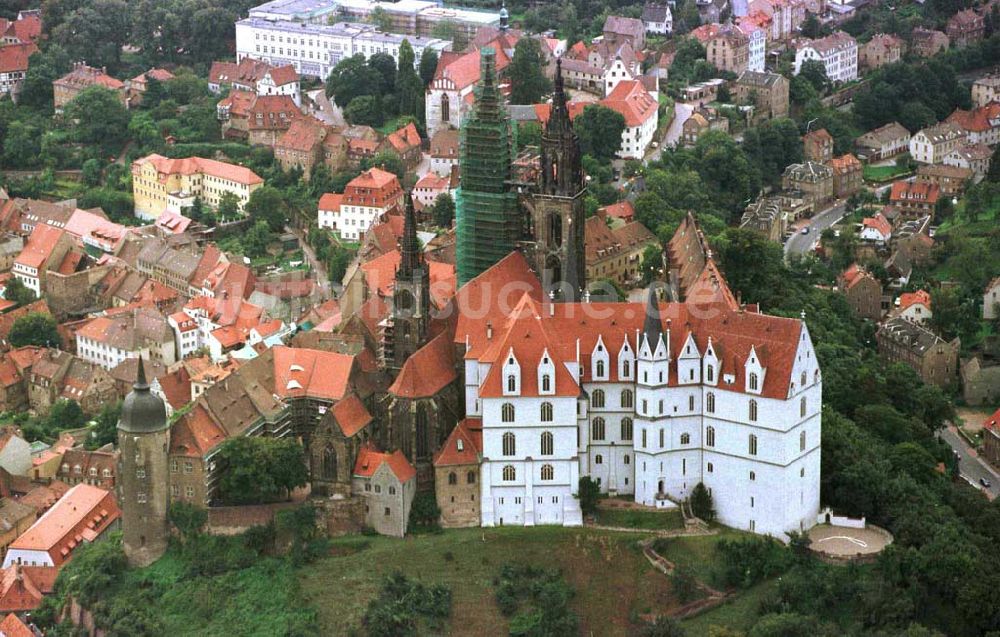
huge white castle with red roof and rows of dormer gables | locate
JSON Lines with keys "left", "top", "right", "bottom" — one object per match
{"left": 456, "top": 266, "right": 822, "bottom": 537}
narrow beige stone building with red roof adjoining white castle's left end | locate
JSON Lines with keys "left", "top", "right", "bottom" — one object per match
{"left": 434, "top": 418, "right": 483, "bottom": 529}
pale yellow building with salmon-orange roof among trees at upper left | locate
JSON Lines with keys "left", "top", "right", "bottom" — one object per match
{"left": 132, "top": 154, "right": 264, "bottom": 220}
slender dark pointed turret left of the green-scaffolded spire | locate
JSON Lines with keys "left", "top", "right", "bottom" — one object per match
{"left": 386, "top": 193, "right": 431, "bottom": 371}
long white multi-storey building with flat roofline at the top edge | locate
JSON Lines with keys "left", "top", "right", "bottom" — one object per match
{"left": 236, "top": 17, "right": 450, "bottom": 79}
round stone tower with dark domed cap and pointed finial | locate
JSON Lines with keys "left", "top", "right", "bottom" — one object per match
{"left": 118, "top": 357, "right": 170, "bottom": 566}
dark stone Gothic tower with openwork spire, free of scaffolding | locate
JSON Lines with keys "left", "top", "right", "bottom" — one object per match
{"left": 528, "top": 60, "right": 587, "bottom": 301}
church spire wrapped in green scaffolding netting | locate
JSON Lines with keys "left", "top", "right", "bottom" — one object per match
{"left": 456, "top": 47, "right": 522, "bottom": 285}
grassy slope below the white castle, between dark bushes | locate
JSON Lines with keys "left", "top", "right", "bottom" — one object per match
{"left": 299, "top": 527, "right": 676, "bottom": 635}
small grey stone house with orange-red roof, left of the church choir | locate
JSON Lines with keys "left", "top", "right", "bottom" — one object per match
{"left": 353, "top": 446, "right": 417, "bottom": 537}
